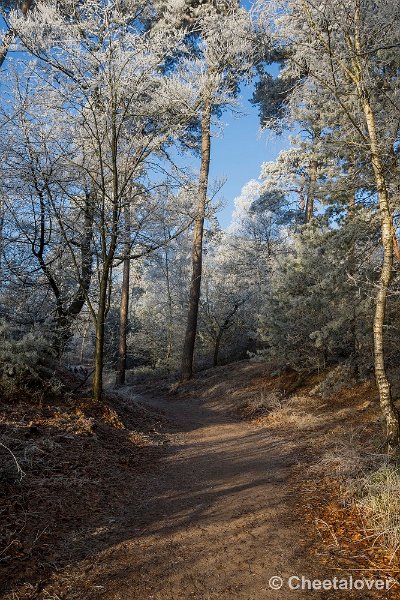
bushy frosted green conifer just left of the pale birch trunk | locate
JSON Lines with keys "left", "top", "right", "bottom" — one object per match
{"left": 260, "top": 208, "right": 378, "bottom": 376}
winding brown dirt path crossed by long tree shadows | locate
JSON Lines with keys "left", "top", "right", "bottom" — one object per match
{"left": 82, "top": 386, "right": 332, "bottom": 600}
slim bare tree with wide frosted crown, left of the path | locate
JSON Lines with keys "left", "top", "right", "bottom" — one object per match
{"left": 10, "top": 0, "right": 200, "bottom": 401}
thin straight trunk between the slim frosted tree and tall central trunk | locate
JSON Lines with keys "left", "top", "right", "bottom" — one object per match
{"left": 115, "top": 205, "right": 131, "bottom": 385}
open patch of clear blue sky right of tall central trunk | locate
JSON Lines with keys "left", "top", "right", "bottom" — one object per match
{"left": 210, "top": 85, "right": 288, "bottom": 228}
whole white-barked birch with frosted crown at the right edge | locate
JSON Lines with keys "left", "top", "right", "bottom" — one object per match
{"left": 262, "top": 0, "right": 400, "bottom": 452}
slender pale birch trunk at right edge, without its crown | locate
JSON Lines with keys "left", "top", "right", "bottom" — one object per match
{"left": 362, "top": 95, "right": 400, "bottom": 454}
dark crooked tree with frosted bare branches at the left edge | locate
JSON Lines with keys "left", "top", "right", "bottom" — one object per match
{"left": 1, "top": 65, "right": 93, "bottom": 353}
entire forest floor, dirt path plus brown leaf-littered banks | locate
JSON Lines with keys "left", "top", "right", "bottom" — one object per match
{"left": 0, "top": 362, "right": 400, "bottom": 600}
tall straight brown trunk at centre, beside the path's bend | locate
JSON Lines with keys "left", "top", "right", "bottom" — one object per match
{"left": 181, "top": 100, "right": 211, "bottom": 381}
